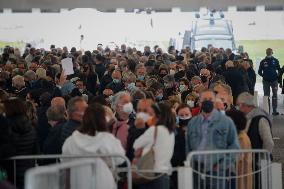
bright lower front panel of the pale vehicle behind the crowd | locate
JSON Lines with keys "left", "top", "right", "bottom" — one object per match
{"left": 194, "top": 39, "right": 233, "bottom": 50}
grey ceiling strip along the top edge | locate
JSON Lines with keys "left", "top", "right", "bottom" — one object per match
{"left": 0, "top": 0, "right": 284, "bottom": 12}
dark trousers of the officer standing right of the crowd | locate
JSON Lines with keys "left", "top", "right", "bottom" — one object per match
{"left": 262, "top": 81, "right": 278, "bottom": 112}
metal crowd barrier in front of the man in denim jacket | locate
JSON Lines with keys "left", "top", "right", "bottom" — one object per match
{"left": 178, "top": 150, "right": 276, "bottom": 189}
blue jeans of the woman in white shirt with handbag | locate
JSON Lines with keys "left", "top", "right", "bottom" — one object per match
{"left": 135, "top": 175, "right": 170, "bottom": 189}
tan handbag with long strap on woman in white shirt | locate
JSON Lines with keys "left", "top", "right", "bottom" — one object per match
{"left": 132, "top": 127, "right": 160, "bottom": 184}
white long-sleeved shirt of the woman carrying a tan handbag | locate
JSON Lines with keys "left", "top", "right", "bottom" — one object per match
{"left": 133, "top": 126, "right": 175, "bottom": 173}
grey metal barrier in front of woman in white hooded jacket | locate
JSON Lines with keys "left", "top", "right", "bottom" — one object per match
{"left": 8, "top": 154, "right": 132, "bottom": 188}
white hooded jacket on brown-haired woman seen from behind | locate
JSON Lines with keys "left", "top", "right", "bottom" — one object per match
{"left": 62, "top": 131, "right": 125, "bottom": 165}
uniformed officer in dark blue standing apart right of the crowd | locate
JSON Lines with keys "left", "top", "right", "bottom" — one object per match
{"left": 258, "top": 48, "right": 281, "bottom": 115}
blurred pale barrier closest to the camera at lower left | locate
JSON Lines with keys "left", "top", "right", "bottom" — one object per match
{"left": 25, "top": 159, "right": 101, "bottom": 189}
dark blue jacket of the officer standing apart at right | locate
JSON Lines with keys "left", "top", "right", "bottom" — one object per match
{"left": 258, "top": 56, "right": 281, "bottom": 82}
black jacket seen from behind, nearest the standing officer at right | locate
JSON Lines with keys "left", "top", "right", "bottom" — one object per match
{"left": 223, "top": 68, "right": 246, "bottom": 102}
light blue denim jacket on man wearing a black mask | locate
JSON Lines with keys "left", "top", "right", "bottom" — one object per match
{"left": 186, "top": 110, "right": 240, "bottom": 173}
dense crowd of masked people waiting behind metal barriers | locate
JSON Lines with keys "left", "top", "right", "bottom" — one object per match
{"left": 0, "top": 44, "right": 281, "bottom": 189}
